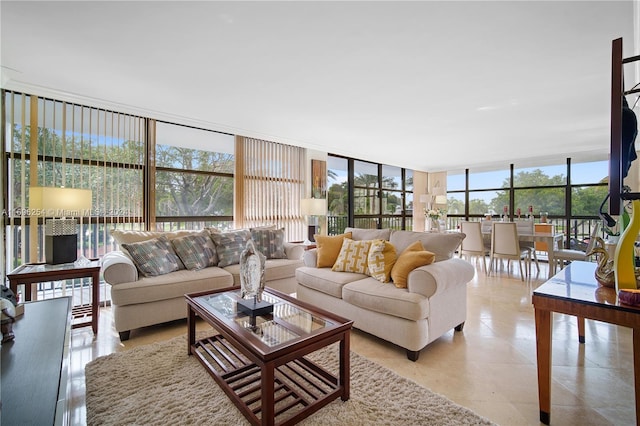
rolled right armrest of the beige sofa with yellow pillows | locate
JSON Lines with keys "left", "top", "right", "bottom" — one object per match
{"left": 407, "top": 258, "right": 475, "bottom": 297}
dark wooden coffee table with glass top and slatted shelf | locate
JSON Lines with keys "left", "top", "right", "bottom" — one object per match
{"left": 185, "top": 287, "right": 353, "bottom": 425}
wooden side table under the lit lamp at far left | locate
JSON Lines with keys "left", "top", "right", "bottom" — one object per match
{"left": 7, "top": 259, "right": 100, "bottom": 334}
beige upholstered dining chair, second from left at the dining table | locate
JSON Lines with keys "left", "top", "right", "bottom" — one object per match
{"left": 489, "top": 222, "right": 531, "bottom": 281}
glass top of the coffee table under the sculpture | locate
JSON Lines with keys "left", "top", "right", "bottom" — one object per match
{"left": 194, "top": 290, "right": 336, "bottom": 346}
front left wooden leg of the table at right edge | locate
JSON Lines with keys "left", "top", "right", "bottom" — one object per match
{"left": 535, "top": 309, "right": 551, "bottom": 425}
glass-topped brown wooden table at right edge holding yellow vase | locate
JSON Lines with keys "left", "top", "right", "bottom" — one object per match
{"left": 533, "top": 262, "right": 640, "bottom": 425}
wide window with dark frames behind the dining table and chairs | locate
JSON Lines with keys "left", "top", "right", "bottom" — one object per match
{"left": 447, "top": 159, "right": 618, "bottom": 247}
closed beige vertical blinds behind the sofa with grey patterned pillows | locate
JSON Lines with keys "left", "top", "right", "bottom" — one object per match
{"left": 235, "top": 137, "right": 305, "bottom": 241}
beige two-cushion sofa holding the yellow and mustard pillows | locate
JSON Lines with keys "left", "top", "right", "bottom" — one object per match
{"left": 296, "top": 228, "right": 475, "bottom": 361}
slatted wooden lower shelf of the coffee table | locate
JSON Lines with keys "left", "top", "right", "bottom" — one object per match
{"left": 191, "top": 335, "right": 343, "bottom": 425}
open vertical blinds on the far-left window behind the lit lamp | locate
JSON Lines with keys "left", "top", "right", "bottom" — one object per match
{"left": 2, "top": 91, "right": 146, "bottom": 270}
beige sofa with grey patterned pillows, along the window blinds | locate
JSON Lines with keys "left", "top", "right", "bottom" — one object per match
{"left": 102, "top": 230, "right": 304, "bottom": 341}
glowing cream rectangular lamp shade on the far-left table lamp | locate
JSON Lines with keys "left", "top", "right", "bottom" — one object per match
{"left": 29, "top": 186, "right": 92, "bottom": 217}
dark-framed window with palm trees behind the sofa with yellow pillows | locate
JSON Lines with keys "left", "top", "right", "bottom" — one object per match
{"left": 327, "top": 155, "right": 413, "bottom": 235}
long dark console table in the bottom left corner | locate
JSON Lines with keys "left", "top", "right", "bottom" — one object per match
{"left": 0, "top": 297, "right": 71, "bottom": 425}
